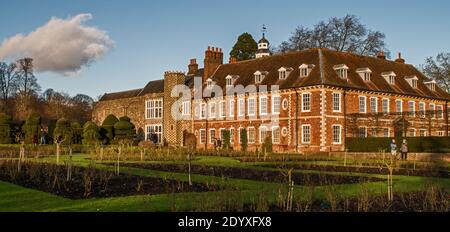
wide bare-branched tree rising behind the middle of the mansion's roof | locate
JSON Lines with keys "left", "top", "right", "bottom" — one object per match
{"left": 278, "top": 15, "right": 389, "bottom": 55}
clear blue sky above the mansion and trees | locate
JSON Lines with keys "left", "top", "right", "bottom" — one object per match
{"left": 0, "top": 0, "right": 450, "bottom": 98}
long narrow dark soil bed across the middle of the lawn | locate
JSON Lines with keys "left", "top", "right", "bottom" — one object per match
{"left": 105, "top": 163, "right": 382, "bottom": 186}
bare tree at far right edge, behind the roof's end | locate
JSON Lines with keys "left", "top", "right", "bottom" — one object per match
{"left": 422, "top": 52, "right": 450, "bottom": 93}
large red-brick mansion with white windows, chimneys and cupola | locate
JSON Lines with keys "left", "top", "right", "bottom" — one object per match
{"left": 93, "top": 35, "right": 450, "bottom": 152}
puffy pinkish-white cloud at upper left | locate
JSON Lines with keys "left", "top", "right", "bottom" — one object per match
{"left": 0, "top": 14, "right": 114, "bottom": 75}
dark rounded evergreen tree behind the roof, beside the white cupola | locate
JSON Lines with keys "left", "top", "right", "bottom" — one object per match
{"left": 230, "top": 32, "right": 258, "bottom": 61}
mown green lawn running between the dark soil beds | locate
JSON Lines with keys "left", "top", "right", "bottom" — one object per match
{"left": 0, "top": 154, "right": 450, "bottom": 212}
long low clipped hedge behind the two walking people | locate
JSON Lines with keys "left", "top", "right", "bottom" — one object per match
{"left": 346, "top": 137, "right": 450, "bottom": 153}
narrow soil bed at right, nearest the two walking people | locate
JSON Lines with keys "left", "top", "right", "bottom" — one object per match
{"left": 258, "top": 164, "right": 449, "bottom": 178}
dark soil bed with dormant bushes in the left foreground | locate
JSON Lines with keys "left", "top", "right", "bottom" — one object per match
{"left": 0, "top": 161, "right": 218, "bottom": 199}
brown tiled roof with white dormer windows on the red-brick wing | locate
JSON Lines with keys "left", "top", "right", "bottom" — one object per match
{"left": 212, "top": 49, "right": 450, "bottom": 99}
